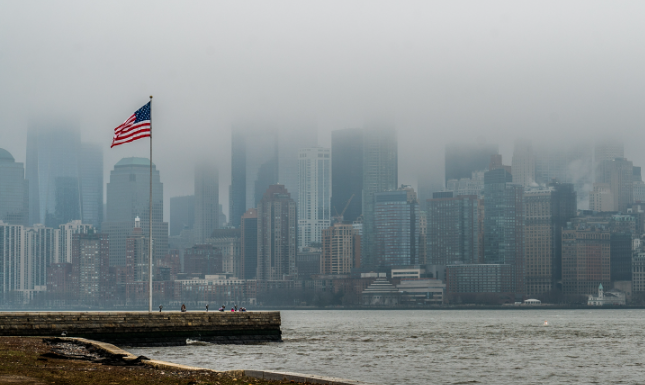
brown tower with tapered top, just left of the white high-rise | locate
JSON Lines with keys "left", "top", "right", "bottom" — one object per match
{"left": 257, "top": 184, "right": 298, "bottom": 280}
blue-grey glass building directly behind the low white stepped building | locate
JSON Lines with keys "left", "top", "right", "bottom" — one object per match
{"left": 373, "top": 186, "right": 420, "bottom": 266}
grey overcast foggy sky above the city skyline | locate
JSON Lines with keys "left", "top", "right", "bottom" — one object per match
{"left": 0, "top": 0, "right": 645, "bottom": 216}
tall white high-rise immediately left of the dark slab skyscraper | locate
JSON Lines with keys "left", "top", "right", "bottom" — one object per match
{"left": 298, "top": 147, "right": 330, "bottom": 248}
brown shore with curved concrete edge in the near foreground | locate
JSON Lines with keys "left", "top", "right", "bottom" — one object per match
{"left": 0, "top": 337, "right": 364, "bottom": 385}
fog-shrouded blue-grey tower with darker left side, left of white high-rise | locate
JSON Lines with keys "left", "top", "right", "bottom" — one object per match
{"left": 229, "top": 124, "right": 276, "bottom": 227}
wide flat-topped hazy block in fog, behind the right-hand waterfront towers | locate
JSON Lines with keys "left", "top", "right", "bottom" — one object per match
{"left": 445, "top": 143, "right": 498, "bottom": 186}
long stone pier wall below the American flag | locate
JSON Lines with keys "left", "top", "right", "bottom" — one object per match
{"left": 0, "top": 311, "right": 282, "bottom": 346}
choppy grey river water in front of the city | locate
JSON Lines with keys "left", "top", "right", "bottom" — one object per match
{"left": 129, "top": 309, "right": 645, "bottom": 385}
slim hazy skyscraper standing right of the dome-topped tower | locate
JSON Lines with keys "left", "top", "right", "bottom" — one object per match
{"left": 195, "top": 164, "right": 219, "bottom": 243}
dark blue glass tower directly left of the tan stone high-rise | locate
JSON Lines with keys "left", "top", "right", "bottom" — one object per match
{"left": 484, "top": 168, "right": 524, "bottom": 293}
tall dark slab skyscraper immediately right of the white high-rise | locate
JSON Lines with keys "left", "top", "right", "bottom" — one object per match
{"left": 331, "top": 128, "right": 363, "bottom": 223}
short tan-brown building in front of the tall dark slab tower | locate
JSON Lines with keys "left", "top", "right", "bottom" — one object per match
{"left": 320, "top": 223, "right": 360, "bottom": 275}
